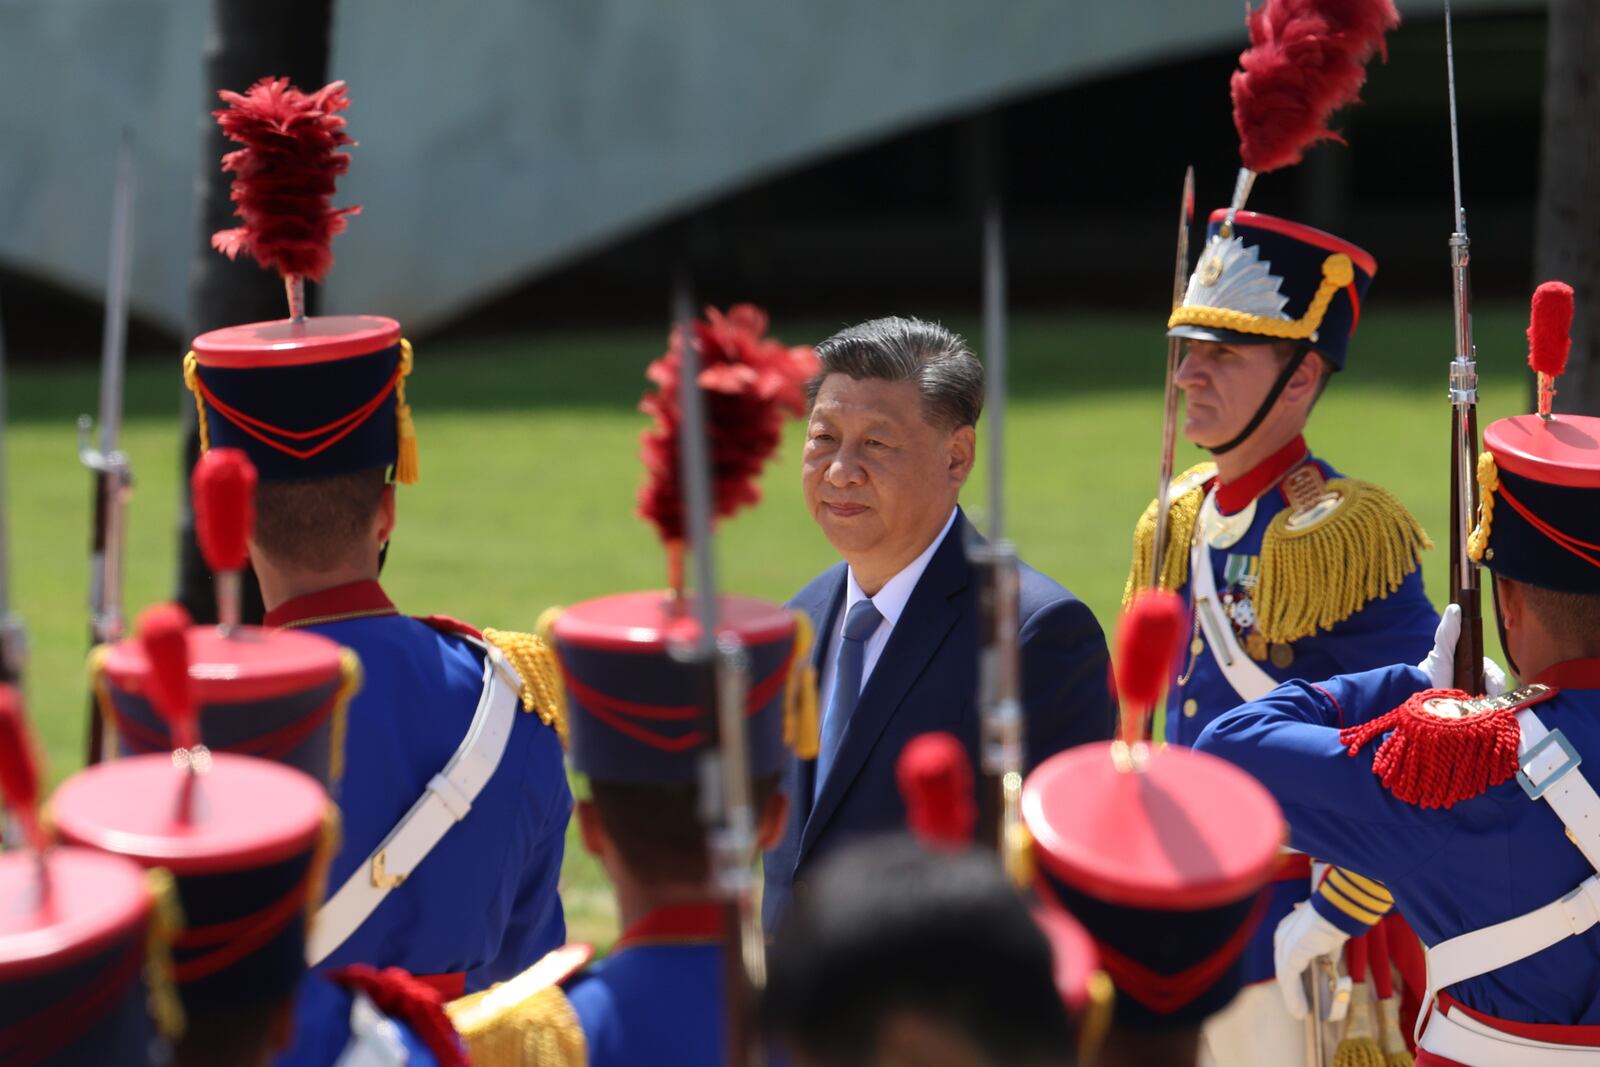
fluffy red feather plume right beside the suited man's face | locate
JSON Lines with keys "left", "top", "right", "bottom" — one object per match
{"left": 638, "top": 304, "right": 819, "bottom": 545}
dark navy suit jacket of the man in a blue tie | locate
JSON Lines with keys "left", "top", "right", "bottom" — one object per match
{"left": 762, "top": 515, "right": 1117, "bottom": 931}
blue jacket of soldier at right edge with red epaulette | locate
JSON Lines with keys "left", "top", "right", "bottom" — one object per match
{"left": 1195, "top": 661, "right": 1600, "bottom": 1025}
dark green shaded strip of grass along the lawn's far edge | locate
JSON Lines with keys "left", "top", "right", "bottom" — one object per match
{"left": 10, "top": 301, "right": 1526, "bottom": 422}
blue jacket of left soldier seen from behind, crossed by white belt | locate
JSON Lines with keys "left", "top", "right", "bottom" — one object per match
{"left": 266, "top": 582, "right": 573, "bottom": 995}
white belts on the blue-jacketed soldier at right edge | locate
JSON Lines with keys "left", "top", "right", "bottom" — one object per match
{"left": 1416, "top": 707, "right": 1600, "bottom": 1064}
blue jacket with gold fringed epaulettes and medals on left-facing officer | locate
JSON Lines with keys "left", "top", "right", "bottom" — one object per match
{"left": 1128, "top": 438, "right": 1438, "bottom": 982}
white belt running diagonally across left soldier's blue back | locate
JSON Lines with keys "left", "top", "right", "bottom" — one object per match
{"left": 306, "top": 641, "right": 522, "bottom": 966}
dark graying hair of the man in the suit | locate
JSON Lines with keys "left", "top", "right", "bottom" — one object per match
{"left": 806, "top": 317, "right": 984, "bottom": 430}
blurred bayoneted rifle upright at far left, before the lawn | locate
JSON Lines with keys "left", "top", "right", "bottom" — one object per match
{"left": 78, "top": 130, "right": 134, "bottom": 765}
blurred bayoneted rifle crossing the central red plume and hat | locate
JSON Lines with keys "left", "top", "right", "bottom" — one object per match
{"left": 672, "top": 269, "right": 766, "bottom": 1067}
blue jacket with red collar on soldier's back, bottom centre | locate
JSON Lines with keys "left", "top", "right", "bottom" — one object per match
{"left": 566, "top": 904, "right": 726, "bottom": 1067}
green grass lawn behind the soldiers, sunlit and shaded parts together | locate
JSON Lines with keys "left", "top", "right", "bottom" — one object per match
{"left": 5, "top": 304, "right": 1528, "bottom": 942}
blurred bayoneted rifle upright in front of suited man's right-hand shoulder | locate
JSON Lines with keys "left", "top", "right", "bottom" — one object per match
{"left": 966, "top": 192, "right": 1022, "bottom": 878}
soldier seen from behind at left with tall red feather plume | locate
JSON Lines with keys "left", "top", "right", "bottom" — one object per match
{"left": 184, "top": 78, "right": 571, "bottom": 995}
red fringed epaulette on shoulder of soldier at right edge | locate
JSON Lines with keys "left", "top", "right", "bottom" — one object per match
{"left": 1339, "top": 685, "right": 1558, "bottom": 808}
